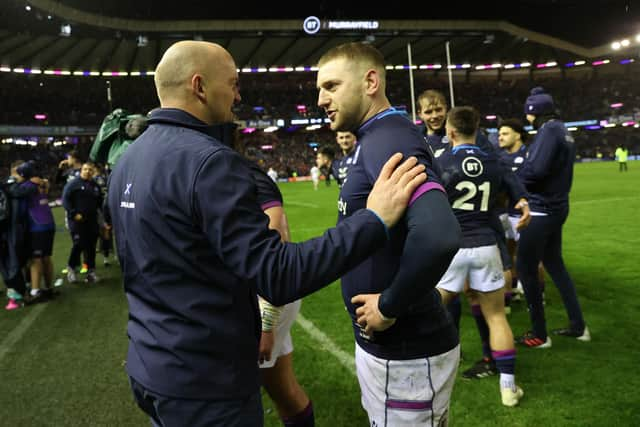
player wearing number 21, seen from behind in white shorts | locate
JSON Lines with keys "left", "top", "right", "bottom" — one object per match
{"left": 438, "top": 107, "right": 528, "bottom": 406}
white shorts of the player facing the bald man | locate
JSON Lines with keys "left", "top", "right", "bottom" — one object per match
{"left": 356, "top": 344, "right": 460, "bottom": 427}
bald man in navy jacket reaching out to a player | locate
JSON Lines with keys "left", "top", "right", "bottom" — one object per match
{"left": 108, "top": 41, "right": 426, "bottom": 427}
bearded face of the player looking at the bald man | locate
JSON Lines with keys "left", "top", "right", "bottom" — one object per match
{"left": 316, "top": 58, "right": 366, "bottom": 131}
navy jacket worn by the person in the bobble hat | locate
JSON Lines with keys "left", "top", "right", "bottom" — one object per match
{"left": 518, "top": 119, "right": 575, "bottom": 213}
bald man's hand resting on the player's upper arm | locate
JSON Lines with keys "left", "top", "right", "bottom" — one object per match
{"left": 367, "top": 153, "right": 427, "bottom": 227}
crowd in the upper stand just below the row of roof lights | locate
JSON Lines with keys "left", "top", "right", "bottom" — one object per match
{"left": 0, "top": 69, "right": 640, "bottom": 126}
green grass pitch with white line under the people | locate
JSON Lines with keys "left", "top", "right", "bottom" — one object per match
{"left": 0, "top": 162, "right": 640, "bottom": 427}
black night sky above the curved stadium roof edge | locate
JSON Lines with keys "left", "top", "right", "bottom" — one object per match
{"left": 8, "top": 0, "right": 640, "bottom": 47}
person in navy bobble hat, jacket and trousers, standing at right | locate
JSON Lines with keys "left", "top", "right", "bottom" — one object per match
{"left": 516, "top": 87, "right": 591, "bottom": 348}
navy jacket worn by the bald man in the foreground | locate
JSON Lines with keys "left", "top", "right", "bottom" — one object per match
{"left": 108, "top": 109, "right": 386, "bottom": 399}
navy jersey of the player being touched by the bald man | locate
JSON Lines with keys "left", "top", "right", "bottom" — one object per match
{"left": 338, "top": 108, "right": 457, "bottom": 360}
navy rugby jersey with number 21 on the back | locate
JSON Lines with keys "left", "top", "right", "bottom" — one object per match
{"left": 438, "top": 145, "right": 524, "bottom": 248}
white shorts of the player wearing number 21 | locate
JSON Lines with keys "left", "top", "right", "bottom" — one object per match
{"left": 437, "top": 245, "right": 504, "bottom": 293}
